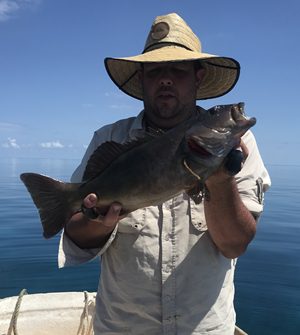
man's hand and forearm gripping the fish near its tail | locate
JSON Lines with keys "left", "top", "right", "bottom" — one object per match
{"left": 65, "top": 193, "right": 125, "bottom": 249}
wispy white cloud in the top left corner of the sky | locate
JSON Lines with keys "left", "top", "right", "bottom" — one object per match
{"left": 0, "top": 0, "right": 41, "bottom": 22}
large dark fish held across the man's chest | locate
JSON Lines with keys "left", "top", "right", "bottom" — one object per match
{"left": 20, "top": 103, "right": 256, "bottom": 238}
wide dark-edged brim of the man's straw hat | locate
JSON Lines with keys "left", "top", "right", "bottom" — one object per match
{"left": 104, "top": 45, "right": 240, "bottom": 100}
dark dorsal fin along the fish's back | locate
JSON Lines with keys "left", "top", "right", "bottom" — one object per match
{"left": 82, "top": 136, "right": 153, "bottom": 181}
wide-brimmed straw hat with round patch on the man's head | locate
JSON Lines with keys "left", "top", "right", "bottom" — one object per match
{"left": 105, "top": 13, "right": 240, "bottom": 100}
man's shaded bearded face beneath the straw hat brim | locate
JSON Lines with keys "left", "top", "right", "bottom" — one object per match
{"left": 141, "top": 62, "right": 203, "bottom": 128}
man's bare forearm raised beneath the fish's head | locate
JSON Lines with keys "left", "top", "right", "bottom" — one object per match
{"left": 204, "top": 141, "right": 256, "bottom": 258}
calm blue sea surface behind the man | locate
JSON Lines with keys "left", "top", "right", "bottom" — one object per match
{"left": 0, "top": 158, "right": 300, "bottom": 335}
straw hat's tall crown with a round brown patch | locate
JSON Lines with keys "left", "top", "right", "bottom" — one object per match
{"left": 144, "top": 13, "right": 201, "bottom": 52}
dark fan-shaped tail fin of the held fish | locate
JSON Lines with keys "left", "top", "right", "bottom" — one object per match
{"left": 20, "top": 173, "right": 79, "bottom": 238}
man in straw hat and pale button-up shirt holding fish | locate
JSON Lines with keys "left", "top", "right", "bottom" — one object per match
{"left": 59, "top": 14, "right": 270, "bottom": 335}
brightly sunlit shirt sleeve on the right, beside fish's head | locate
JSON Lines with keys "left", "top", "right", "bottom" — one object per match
{"left": 236, "top": 131, "right": 271, "bottom": 217}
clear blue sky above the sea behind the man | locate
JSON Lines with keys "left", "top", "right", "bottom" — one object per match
{"left": 0, "top": 0, "right": 300, "bottom": 164}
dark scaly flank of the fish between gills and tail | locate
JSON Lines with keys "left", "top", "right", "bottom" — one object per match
{"left": 80, "top": 121, "right": 194, "bottom": 213}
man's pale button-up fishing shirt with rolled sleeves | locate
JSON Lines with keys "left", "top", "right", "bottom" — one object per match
{"left": 58, "top": 109, "right": 270, "bottom": 335}
